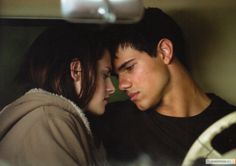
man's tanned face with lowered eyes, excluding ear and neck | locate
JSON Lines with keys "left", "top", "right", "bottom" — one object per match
{"left": 114, "top": 46, "right": 170, "bottom": 110}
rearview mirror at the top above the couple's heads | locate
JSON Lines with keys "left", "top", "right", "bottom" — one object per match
{"left": 61, "top": 0, "right": 144, "bottom": 23}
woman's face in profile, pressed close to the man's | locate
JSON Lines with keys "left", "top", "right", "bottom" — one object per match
{"left": 88, "top": 51, "right": 115, "bottom": 115}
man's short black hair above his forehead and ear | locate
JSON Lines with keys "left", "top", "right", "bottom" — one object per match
{"left": 107, "top": 8, "right": 185, "bottom": 67}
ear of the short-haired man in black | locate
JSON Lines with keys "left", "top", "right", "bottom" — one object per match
{"left": 157, "top": 38, "right": 174, "bottom": 64}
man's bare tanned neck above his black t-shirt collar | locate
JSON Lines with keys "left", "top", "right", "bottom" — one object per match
{"left": 156, "top": 61, "right": 211, "bottom": 117}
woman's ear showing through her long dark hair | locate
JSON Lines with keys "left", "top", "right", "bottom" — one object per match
{"left": 70, "top": 59, "right": 81, "bottom": 81}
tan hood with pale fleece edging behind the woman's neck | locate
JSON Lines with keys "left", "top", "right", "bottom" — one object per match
{"left": 0, "top": 89, "right": 91, "bottom": 140}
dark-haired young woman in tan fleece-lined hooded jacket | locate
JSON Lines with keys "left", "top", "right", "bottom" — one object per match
{"left": 0, "top": 26, "right": 114, "bottom": 166}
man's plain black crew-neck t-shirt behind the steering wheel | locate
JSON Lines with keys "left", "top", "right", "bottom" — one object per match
{"left": 89, "top": 94, "right": 236, "bottom": 165}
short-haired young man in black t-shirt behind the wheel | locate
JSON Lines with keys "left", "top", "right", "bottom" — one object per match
{"left": 90, "top": 8, "right": 236, "bottom": 165}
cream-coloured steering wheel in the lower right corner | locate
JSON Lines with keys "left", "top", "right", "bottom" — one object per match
{"left": 182, "top": 111, "right": 236, "bottom": 166}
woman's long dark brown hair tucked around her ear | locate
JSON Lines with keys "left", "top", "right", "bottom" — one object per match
{"left": 16, "top": 25, "right": 104, "bottom": 108}
